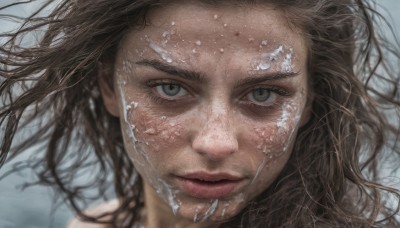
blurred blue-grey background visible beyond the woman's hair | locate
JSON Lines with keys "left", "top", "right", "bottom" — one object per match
{"left": 0, "top": 0, "right": 400, "bottom": 228}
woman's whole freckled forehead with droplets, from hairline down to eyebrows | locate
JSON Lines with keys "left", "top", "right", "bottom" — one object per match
{"left": 120, "top": 1, "right": 307, "bottom": 77}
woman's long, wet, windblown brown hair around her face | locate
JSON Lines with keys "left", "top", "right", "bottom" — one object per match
{"left": 0, "top": 0, "right": 400, "bottom": 227}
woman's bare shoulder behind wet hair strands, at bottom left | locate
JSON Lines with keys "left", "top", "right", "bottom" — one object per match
{"left": 66, "top": 199, "right": 119, "bottom": 228}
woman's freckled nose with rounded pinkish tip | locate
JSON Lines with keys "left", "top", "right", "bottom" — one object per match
{"left": 192, "top": 105, "right": 238, "bottom": 161}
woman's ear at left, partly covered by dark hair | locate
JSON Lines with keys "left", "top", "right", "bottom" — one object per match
{"left": 97, "top": 62, "right": 119, "bottom": 117}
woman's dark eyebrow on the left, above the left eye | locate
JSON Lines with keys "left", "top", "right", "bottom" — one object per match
{"left": 136, "top": 59, "right": 205, "bottom": 83}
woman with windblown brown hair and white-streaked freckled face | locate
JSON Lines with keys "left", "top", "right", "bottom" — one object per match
{"left": 0, "top": 0, "right": 400, "bottom": 227}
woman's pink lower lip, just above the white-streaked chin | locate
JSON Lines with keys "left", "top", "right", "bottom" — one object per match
{"left": 178, "top": 177, "right": 240, "bottom": 199}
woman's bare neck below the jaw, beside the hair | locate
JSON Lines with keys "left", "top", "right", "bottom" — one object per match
{"left": 144, "top": 181, "right": 218, "bottom": 228}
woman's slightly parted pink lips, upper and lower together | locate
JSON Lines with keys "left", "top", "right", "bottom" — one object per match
{"left": 176, "top": 172, "right": 244, "bottom": 199}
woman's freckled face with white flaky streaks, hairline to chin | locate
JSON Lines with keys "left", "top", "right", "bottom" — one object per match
{"left": 106, "top": 2, "right": 308, "bottom": 221}
